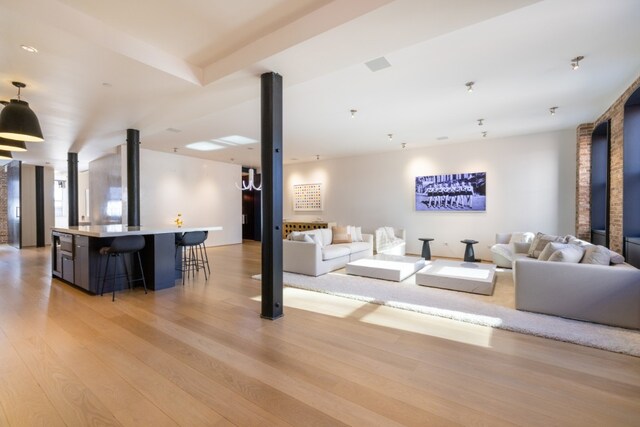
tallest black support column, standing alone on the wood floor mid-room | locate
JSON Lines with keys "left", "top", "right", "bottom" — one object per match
{"left": 261, "top": 72, "right": 283, "bottom": 320}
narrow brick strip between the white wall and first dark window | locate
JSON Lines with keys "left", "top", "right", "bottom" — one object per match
{"left": 576, "top": 123, "right": 594, "bottom": 240}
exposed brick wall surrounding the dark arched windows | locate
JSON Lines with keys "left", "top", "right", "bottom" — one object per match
{"left": 576, "top": 77, "right": 640, "bottom": 253}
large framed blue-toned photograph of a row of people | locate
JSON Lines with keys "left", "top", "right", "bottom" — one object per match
{"left": 416, "top": 172, "right": 487, "bottom": 212}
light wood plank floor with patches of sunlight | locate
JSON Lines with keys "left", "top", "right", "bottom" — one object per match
{"left": 0, "top": 243, "right": 640, "bottom": 427}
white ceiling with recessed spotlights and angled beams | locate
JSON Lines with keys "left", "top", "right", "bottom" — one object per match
{"left": 0, "top": 0, "right": 640, "bottom": 173}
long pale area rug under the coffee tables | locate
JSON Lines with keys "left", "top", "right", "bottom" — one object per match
{"left": 253, "top": 272, "right": 640, "bottom": 357}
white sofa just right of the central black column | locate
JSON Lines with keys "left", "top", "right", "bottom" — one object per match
{"left": 282, "top": 228, "right": 373, "bottom": 276}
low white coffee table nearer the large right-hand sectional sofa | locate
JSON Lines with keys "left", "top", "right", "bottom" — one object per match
{"left": 416, "top": 259, "right": 496, "bottom": 295}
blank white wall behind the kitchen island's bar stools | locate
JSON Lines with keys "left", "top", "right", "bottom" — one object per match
{"left": 140, "top": 150, "right": 242, "bottom": 246}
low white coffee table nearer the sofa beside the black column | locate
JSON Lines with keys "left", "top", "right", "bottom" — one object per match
{"left": 345, "top": 254, "right": 425, "bottom": 282}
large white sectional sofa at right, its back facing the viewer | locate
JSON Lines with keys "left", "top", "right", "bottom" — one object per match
{"left": 491, "top": 233, "right": 640, "bottom": 329}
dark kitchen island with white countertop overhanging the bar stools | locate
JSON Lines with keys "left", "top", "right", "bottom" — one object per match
{"left": 51, "top": 224, "right": 222, "bottom": 294}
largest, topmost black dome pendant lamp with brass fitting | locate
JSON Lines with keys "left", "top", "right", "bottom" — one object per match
{"left": 0, "top": 82, "right": 44, "bottom": 142}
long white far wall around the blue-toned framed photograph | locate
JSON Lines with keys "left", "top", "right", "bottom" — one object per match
{"left": 283, "top": 130, "right": 576, "bottom": 259}
